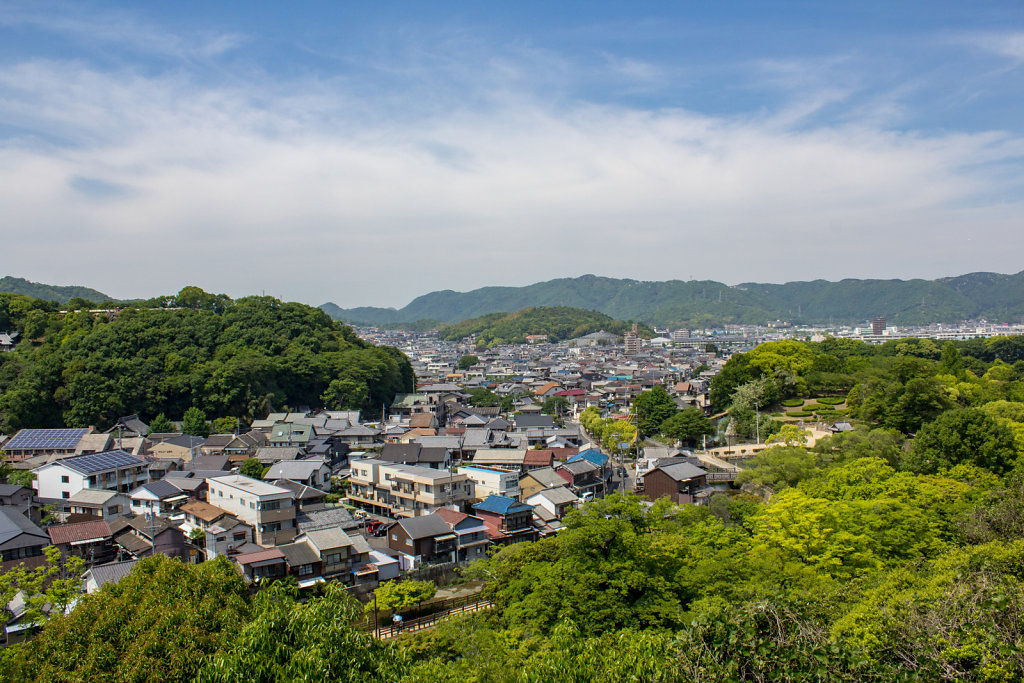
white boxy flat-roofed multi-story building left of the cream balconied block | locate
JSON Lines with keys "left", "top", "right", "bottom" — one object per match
{"left": 207, "top": 474, "right": 297, "bottom": 546}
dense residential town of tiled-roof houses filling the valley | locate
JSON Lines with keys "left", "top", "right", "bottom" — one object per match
{"left": 6, "top": 319, "right": 1024, "bottom": 642}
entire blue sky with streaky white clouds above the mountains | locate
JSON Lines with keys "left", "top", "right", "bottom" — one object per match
{"left": 0, "top": 0, "right": 1024, "bottom": 306}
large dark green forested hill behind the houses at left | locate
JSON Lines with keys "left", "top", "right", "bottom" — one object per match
{"left": 0, "top": 287, "right": 415, "bottom": 433}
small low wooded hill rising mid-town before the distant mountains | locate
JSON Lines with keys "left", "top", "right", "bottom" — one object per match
{"left": 439, "top": 306, "right": 653, "bottom": 346}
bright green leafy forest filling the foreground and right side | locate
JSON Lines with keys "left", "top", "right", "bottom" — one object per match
{"left": 0, "top": 338, "right": 1024, "bottom": 683}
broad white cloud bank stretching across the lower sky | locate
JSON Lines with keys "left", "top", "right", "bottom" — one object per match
{"left": 0, "top": 30, "right": 1024, "bottom": 306}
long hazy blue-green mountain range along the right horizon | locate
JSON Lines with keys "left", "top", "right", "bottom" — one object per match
{"left": 321, "top": 271, "right": 1024, "bottom": 327}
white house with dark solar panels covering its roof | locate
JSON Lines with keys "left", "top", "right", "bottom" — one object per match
{"left": 32, "top": 451, "right": 150, "bottom": 512}
